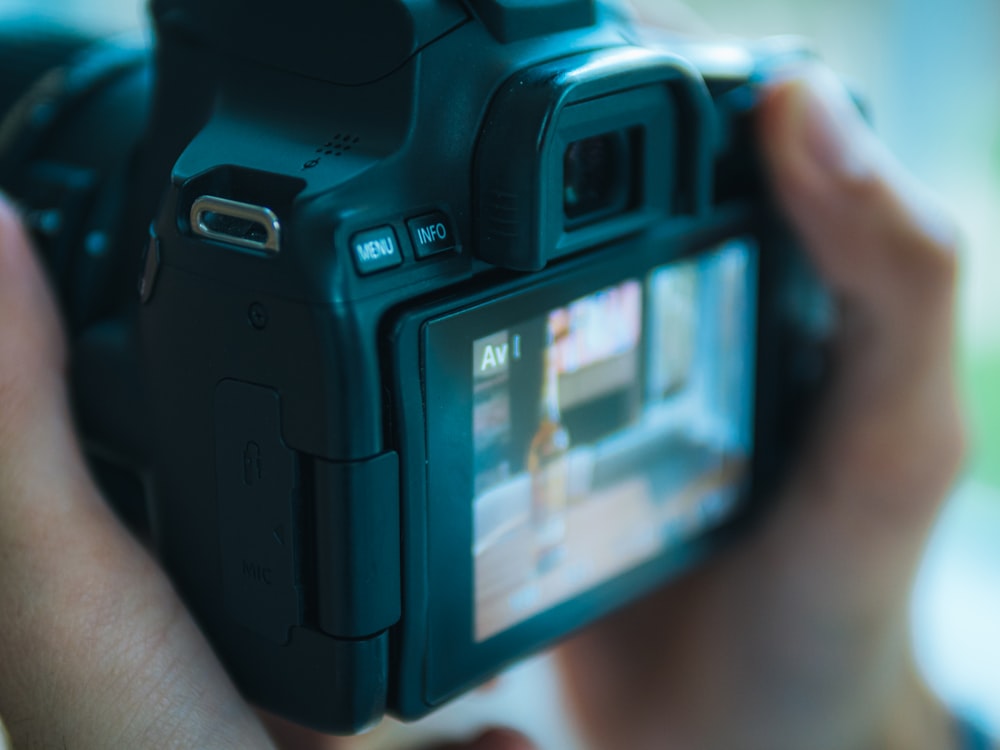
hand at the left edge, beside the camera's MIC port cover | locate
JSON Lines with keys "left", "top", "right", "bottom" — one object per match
{"left": 0, "top": 201, "right": 268, "bottom": 748}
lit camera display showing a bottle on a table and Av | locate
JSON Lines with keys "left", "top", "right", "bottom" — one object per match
{"left": 470, "top": 242, "right": 756, "bottom": 642}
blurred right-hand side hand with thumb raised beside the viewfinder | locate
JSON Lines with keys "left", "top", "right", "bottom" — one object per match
{"left": 562, "top": 66, "right": 963, "bottom": 750}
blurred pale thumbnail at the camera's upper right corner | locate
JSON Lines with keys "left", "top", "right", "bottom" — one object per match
{"left": 792, "top": 65, "right": 876, "bottom": 180}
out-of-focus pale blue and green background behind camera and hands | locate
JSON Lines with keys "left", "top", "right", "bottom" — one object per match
{"left": 0, "top": 0, "right": 1000, "bottom": 750}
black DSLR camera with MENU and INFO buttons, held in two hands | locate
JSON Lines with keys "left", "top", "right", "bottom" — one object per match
{"left": 0, "top": 0, "right": 824, "bottom": 733}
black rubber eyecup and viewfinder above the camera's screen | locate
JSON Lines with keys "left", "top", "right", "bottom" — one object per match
{"left": 473, "top": 48, "right": 714, "bottom": 271}
